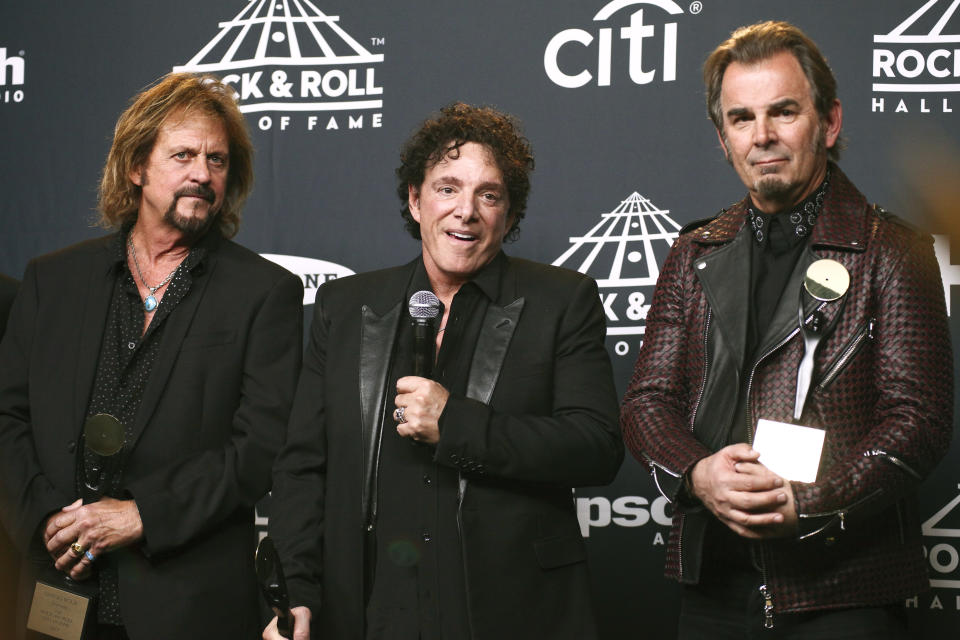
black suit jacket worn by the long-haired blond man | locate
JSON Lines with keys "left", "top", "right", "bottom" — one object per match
{"left": 0, "top": 231, "right": 303, "bottom": 640}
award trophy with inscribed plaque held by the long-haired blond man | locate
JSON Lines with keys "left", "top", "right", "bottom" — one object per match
{"left": 27, "top": 413, "right": 124, "bottom": 640}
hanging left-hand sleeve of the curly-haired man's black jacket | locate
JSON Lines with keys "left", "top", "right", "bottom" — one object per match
{"left": 270, "top": 287, "right": 329, "bottom": 616}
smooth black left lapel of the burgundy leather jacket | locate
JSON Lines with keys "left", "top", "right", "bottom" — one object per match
{"left": 693, "top": 232, "right": 752, "bottom": 371}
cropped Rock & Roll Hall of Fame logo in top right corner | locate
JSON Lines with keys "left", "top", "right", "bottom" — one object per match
{"left": 872, "top": 0, "right": 960, "bottom": 113}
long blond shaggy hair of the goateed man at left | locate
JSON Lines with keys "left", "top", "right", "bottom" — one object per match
{"left": 99, "top": 73, "right": 253, "bottom": 238}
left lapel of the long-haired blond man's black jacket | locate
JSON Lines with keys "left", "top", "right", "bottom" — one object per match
{"left": 71, "top": 242, "right": 114, "bottom": 437}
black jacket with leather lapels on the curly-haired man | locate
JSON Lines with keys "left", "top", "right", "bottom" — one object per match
{"left": 270, "top": 256, "right": 623, "bottom": 640}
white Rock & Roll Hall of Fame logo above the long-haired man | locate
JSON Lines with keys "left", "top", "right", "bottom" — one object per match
{"left": 173, "top": 0, "right": 383, "bottom": 131}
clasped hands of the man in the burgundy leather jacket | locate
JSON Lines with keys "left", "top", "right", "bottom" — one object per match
{"left": 690, "top": 444, "right": 797, "bottom": 539}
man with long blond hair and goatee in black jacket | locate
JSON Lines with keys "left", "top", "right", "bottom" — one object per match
{"left": 0, "top": 74, "right": 302, "bottom": 640}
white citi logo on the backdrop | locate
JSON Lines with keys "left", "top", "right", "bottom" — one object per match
{"left": 543, "top": 0, "right": 688, "bottom": 89}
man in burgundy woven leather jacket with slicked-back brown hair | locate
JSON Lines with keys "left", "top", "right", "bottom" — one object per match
{"left": 621, "top": 22, "right": 953, "bottom": 638}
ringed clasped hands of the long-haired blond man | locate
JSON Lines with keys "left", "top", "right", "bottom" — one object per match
{"left": 43, "top": 498, "right": 143, "bottom": 580}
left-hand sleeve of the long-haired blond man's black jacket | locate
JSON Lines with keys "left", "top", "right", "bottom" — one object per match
{"left": 0, "top": 262, "right": 72, "bottom": 550}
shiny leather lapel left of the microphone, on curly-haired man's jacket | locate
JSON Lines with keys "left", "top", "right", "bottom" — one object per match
{"left": 359, "top": 300, "right": 403, "bottom": 517}
